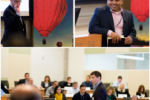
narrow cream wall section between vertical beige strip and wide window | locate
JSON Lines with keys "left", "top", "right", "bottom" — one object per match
{"left": 68, "top": 48, "right": 85, "bottom": 86}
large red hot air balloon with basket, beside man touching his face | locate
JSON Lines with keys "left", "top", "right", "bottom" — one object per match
{"left": 33, "top": 0, "right": 67, "bottom": 44}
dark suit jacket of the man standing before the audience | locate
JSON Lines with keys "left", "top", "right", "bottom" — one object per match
{"left": 92, "top": 82, "right": 107, "bottom": 100}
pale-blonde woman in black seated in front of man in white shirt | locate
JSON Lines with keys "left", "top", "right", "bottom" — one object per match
{"left": 116, "top": 83, "right": 130, "bottom": 97}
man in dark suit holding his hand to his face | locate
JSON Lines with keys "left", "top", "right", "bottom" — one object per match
{"left": 1, "top": 0, "right": 28, "bottom": 47}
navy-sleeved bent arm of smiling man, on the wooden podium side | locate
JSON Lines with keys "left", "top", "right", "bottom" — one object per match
{"left": 89, "top": 8, "right": 109, "bottom": 37}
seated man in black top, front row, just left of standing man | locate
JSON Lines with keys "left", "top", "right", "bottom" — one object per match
{"left": 72, "top": 84, "right": 91, "bottom": 100}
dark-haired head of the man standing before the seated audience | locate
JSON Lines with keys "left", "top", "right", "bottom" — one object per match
{"left": 90, "top": 71, "right": 101, "bottom": 85}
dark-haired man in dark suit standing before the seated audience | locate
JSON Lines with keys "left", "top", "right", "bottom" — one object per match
{"left": 90, "top": 71, "right": 107, "bottom": 100}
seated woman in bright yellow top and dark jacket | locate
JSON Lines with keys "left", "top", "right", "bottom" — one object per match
{"left": 50, "top": 86, "right": 67, "bottom": 100}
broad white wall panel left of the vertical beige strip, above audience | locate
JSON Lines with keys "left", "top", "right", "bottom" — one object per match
{"left": 30, "top": 48, "right": 64, "bottom": 87}
